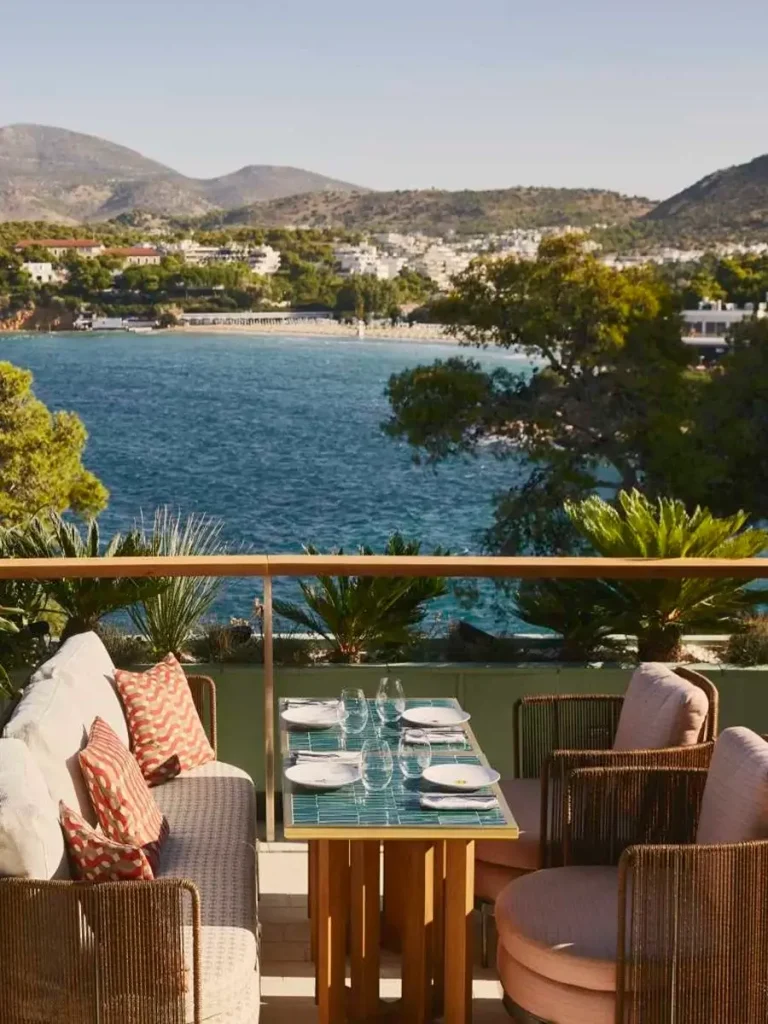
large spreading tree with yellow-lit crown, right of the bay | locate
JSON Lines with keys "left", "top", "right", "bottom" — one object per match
{"left": 384, "top": 236, "right": 702, "bottom": 554}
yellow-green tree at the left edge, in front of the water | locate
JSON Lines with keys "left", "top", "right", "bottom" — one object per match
{"left": 0, "top": 362, "right": 109, "bottom": 525}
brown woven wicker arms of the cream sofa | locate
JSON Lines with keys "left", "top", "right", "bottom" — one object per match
{"left": 0, "top": 676, "right": 217, "bottom": 1024}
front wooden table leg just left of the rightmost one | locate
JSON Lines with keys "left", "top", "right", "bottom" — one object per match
{"left": 400, "top": 842, "right": 434, "bottom": 1024}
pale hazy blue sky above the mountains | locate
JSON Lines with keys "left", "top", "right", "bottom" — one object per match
{"left": 0, "top": 0, "right": 768, "bottom": 199}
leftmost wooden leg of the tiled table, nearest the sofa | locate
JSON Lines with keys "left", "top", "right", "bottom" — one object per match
{"left": 316, "top": 840, "right": 349, "bottom": 1024}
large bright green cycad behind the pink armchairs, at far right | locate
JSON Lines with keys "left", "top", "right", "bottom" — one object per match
{"left": 565, "top": 490, "right": 768, "bottom": 660}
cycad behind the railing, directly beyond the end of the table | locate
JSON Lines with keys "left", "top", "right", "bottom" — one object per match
{"left": 274, "top": 534, "right": 447, "bottom": 662}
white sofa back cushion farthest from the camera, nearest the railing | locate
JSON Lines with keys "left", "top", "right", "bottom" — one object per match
{"left": 32, "top": 633, "right": 128, "bottom": 746}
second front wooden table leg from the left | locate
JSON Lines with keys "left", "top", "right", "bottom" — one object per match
{"left": 350, "top": 840, "right": 381, "bottom": 1021}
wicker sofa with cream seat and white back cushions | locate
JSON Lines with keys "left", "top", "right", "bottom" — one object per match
{"left": 0, "top": 633, "right": 260, "bottom": 1024}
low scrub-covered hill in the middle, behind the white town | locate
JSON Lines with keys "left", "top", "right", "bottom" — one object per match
{"left": 211, "top": 187, "right": 653, "bottom": 236}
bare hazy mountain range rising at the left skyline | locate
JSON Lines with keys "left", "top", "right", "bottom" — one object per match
{"left": 0, "top": 125, "right": 357, "bottom": 223}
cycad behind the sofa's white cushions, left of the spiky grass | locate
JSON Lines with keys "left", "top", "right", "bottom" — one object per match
{"left": 6, "top": 512, "right": 165, "bottom": 640}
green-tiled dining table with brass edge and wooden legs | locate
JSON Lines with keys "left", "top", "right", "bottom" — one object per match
{"left": 280, "top": 697, "right": 518, "bottom": 1024}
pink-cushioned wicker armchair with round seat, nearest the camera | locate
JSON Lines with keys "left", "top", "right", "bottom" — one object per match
{"left": 497, "top": 729, "right": 768, "bottom": 1024}
